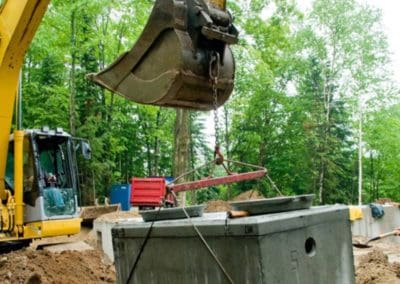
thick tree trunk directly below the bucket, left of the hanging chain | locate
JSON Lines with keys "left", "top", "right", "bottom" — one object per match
{"left": 173, "top": 109, "right": 190, "bottom": 206}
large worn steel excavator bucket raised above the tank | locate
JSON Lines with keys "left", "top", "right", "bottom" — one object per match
{"left": 88, "top": 0, "right": 238, "bottom": 110}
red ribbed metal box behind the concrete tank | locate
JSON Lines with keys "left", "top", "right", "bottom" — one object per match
{"left": 131, "top": 177, "right": 170, "bottom": 207}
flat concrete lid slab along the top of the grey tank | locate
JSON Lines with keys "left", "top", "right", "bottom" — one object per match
{"left": 112, "top": 205, "right": 350, "bottom": 238}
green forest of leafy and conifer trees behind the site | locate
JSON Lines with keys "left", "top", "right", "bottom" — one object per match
{"left": 22, "top": 0, "right": 400, "bottom": 204}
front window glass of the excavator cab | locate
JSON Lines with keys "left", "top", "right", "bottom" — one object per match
{"left": 37, "top": 136, "right": 76, "bottom": 217}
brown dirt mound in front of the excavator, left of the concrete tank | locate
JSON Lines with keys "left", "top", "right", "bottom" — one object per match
{"left": 0, "top": 249, "right": 116, "bottom": 284}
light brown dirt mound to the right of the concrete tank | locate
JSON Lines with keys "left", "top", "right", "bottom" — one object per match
{"left": 356, "top": 250, "right": 400, "bottom": 284}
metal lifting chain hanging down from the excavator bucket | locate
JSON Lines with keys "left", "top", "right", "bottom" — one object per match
{"left": 210, "top": 51, "right": 220, "bottom": 148}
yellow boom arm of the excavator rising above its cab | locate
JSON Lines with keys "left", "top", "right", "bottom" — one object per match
{"left": 0, "top": 0, "right": 50, "bottom": 201}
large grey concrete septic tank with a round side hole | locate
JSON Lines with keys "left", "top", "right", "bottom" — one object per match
{"left": 112, "top": 206, "right": 354, "bottom": 284}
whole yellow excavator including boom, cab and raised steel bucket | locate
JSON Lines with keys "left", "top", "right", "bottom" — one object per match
{"left": 0, "top": 0, "right": 238, "bottom": 247}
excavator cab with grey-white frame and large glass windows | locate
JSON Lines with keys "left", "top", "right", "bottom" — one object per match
{"left": 5, "top": 128, "right": 80, "bottom": 224}
